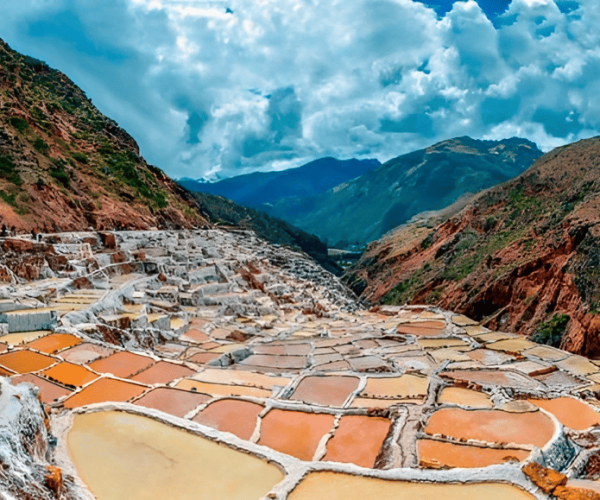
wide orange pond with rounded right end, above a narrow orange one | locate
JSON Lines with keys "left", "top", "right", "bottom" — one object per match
{"left": 425, "top": 408, "right": 555, "bottom": 448}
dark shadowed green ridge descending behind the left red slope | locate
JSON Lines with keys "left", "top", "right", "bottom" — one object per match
{"left": 194, "top": 193, "right": 342, "bottom": 275}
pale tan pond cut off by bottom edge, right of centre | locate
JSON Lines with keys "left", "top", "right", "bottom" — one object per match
{"left": 288, "top": 472, "right": 535, "bottom": 500}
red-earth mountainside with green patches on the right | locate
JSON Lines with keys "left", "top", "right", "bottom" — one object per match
{"left": 345, "top": 138, "right": 600, "bottom": 357}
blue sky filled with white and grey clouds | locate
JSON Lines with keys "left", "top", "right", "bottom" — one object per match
{"left": 0, "top": 0, "right": 600, "bottom": 179}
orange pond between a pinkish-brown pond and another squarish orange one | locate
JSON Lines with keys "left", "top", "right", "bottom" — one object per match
{"left": 258, "top": 410, "right": 335, "bottom": 460}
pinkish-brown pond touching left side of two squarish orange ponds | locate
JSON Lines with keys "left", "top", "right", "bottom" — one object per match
{"left": 192, "top": 399, "right": 264, "bottom": 440}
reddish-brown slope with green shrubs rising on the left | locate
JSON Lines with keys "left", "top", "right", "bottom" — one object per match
{"left": 0, "top": 40, "right": 206, "bottom": 232}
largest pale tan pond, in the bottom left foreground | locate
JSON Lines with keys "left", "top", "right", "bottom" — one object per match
{"left": 67, "top": 411, "right": 283, "bottom": 500}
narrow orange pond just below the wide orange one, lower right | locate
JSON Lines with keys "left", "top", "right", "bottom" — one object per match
{"left": 417, "top": 439, "right": 529, "bottom": 468}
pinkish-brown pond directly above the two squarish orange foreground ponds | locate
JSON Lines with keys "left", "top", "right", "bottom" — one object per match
{"left": 290, "top": 376, "right": 360, "bottom": 406}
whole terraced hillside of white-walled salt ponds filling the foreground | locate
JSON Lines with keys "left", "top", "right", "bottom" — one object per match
{"left": 0, "top": 229, "right": 600, "bottom": 500}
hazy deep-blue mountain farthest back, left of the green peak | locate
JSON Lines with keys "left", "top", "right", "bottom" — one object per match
{"left": 179, "top": 158, "right": 380, "bottom": 208}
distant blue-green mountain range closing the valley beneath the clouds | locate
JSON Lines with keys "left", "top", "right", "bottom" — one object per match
{"left": 180, "top": 137, "right": 542, "bottom": 247}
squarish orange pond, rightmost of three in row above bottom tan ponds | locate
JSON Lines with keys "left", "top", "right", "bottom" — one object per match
{"left": 323, "top": 415, "right": 392, "bottom": 468}
